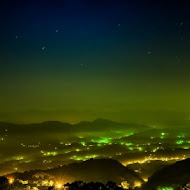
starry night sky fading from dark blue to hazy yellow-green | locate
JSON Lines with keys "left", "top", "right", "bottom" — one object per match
{"left": 0, "top": 0, "right": 190, "bottom": 125}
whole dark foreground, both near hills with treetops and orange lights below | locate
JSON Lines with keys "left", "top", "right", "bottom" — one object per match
{"left": 0, "top": 158, "right": 190, "bottom": 190}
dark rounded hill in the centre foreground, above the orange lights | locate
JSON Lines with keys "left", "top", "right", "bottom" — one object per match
{"left": 6, "top": 159, "right": 143, "bottom": 185}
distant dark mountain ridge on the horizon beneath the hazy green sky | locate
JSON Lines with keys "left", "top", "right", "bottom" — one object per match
{"left": 0, "top": 118, "right": 150, "bottom": 133}
